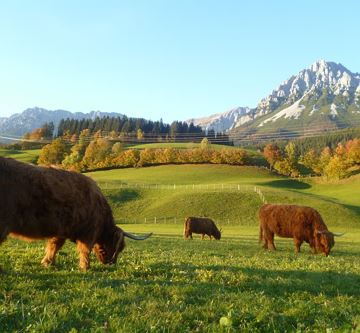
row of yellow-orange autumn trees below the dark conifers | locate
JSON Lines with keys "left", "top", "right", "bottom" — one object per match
{"left": 38, "top": 129, "right": 248, "bottom": 171}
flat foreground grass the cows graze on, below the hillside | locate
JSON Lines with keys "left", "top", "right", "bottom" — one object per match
{"left": 0, "top": 225, "right": 360, "bottom": 332}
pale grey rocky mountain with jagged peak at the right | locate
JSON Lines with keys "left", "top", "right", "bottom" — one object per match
{"left": 187, "top": 59, "right": 360, "bottom": 133}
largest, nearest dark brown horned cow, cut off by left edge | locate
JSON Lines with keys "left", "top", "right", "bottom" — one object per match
{"left": 0, "top": 157, "right": 151, "bottom": 270}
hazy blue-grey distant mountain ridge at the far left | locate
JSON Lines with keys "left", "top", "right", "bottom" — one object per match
{"left": 0, "top": 107, "right": 123, "bottom": 136}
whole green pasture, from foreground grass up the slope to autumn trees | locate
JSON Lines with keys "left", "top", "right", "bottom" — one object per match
{"left": 0, "top": 152, "right": 360, "bottom": 333}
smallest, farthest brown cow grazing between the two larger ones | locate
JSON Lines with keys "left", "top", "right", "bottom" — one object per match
{"left": 184, "top": 217, "right": 221, "bottom": 240}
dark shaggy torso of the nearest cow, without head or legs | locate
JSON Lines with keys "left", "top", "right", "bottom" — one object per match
{"left": 0, "top": 158, "right": 112, "bottom": 239}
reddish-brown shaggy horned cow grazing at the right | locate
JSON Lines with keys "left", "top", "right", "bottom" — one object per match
{"left": 259, "top": 204, "right": 342, "bottom": 256}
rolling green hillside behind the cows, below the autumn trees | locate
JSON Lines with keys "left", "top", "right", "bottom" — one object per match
{"left": 87, "top": 165, "right": 360, "bottom": 229}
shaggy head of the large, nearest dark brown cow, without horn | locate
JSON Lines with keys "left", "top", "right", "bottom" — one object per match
{"left": 94, "top": 227, "right": 125, "bottom": 264}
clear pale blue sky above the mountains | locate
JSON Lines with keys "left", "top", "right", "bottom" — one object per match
{"left": 0, "top": 0, "right": 360, "bottom": 122}
